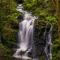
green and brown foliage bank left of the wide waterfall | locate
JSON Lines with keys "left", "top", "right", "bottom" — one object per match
{"left": 0, "top": 0, "right": 19, "bottom": 60}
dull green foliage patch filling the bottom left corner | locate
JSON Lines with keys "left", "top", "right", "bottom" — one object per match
{"left": 0, "top": 44, "right": 12, "bottom": 60}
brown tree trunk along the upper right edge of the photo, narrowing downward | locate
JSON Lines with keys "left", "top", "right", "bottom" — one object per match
{"left": 52, "top": 0, "right": 60, "bottom": 39}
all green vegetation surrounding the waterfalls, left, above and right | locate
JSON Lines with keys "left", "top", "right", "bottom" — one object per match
{"left": 0, "top": 0, "right": 60, "bottom": 60}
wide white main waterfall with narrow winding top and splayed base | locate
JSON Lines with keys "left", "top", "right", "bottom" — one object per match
{"left": 13, "top": 4, "right": 36, "bottom": 60}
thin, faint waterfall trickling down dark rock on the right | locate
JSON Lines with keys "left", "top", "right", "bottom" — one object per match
{"left": 44, "top": 25, "right": 53, "bottom": 60}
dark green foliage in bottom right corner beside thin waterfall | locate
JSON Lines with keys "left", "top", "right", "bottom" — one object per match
{"left": 52, "top": 39, "right": 60, "bottom": 60}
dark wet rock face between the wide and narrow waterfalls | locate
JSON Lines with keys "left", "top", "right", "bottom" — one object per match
{"left": 34, "top": 20, "right": 46, "bottom": 56}
